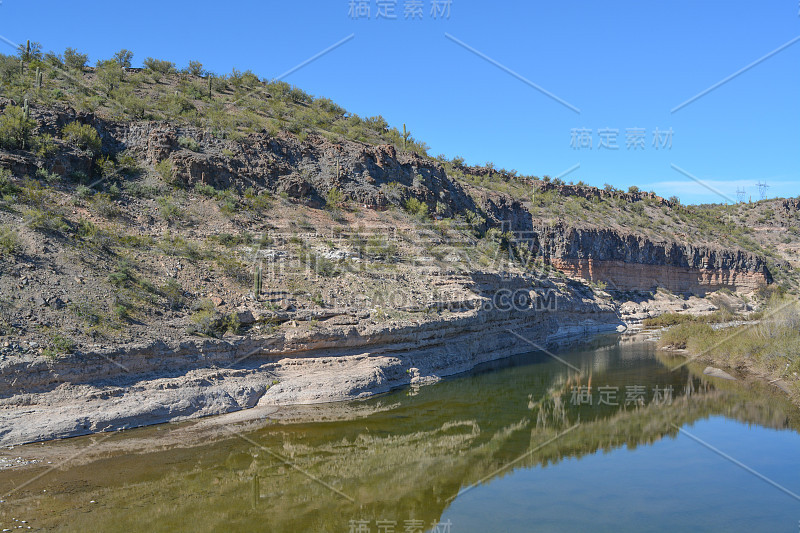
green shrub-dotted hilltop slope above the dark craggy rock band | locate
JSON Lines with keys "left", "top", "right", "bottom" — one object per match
{"left": 0, "top": 42, "right": 428, "bottom": 154}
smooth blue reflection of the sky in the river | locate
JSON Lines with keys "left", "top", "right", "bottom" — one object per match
{"left": 442, "top": 416, "right": 800, "bottom": 533}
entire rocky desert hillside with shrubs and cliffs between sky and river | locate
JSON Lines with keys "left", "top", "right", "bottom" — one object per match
{"left": 0, "top": 46, "right": 800, "bottom": 443}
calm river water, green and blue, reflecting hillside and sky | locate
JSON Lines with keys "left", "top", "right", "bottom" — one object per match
{"left": 0, "top": 338, "right": 800, "bottom": 532}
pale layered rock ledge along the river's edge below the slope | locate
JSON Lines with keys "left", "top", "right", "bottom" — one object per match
{"left": 0, "top": 296, "right": 624, "bottom": 445}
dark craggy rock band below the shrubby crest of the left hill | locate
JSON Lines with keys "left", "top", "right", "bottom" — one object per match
{"left": 107, "top": 123, "right": 475, "bottom": 216}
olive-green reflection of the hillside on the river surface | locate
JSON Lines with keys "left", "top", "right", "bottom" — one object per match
{"left": 0, "top": 338, "right": 798, "bottom": 531}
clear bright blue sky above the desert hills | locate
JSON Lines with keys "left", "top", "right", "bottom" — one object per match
{"left": 0, "top": 0, "right": 800, "bottom": 202}
